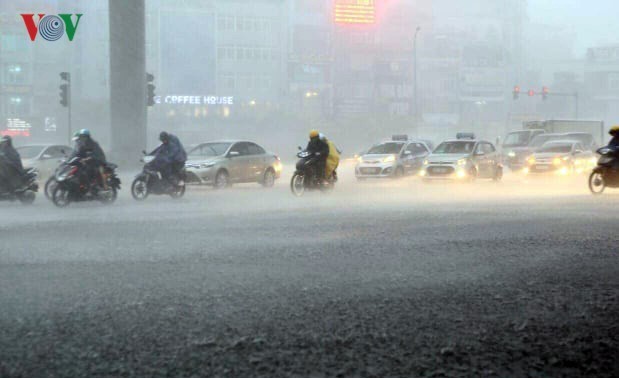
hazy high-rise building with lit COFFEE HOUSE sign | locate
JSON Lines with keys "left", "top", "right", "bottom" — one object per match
{"left": 146, "top": 0, "right": 287, "bottom": 140}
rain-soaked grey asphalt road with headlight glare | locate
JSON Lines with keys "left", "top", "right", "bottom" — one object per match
{"left": 0, "top": 169, "right": 619, "bottom": 377}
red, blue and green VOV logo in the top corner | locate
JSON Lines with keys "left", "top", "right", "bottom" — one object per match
{"left": 20, "top": 13, "right": 82, "bottom": 42}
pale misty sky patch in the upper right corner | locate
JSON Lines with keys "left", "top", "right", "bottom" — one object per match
{"left": 529, "top": 0, "right": 619, "bottom": 54}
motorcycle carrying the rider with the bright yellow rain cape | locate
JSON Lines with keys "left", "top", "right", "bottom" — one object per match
{"left": 290, "top": 147, "right": 337, "bottom": 197}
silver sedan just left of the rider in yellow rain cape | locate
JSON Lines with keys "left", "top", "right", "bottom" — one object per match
{"left": 185, "top": 140, "right": 282, "bottom": 189}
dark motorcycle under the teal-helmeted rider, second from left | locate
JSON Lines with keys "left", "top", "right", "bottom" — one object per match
{"left": 52, "top": 157, "right": 120, "bottom": 207}
